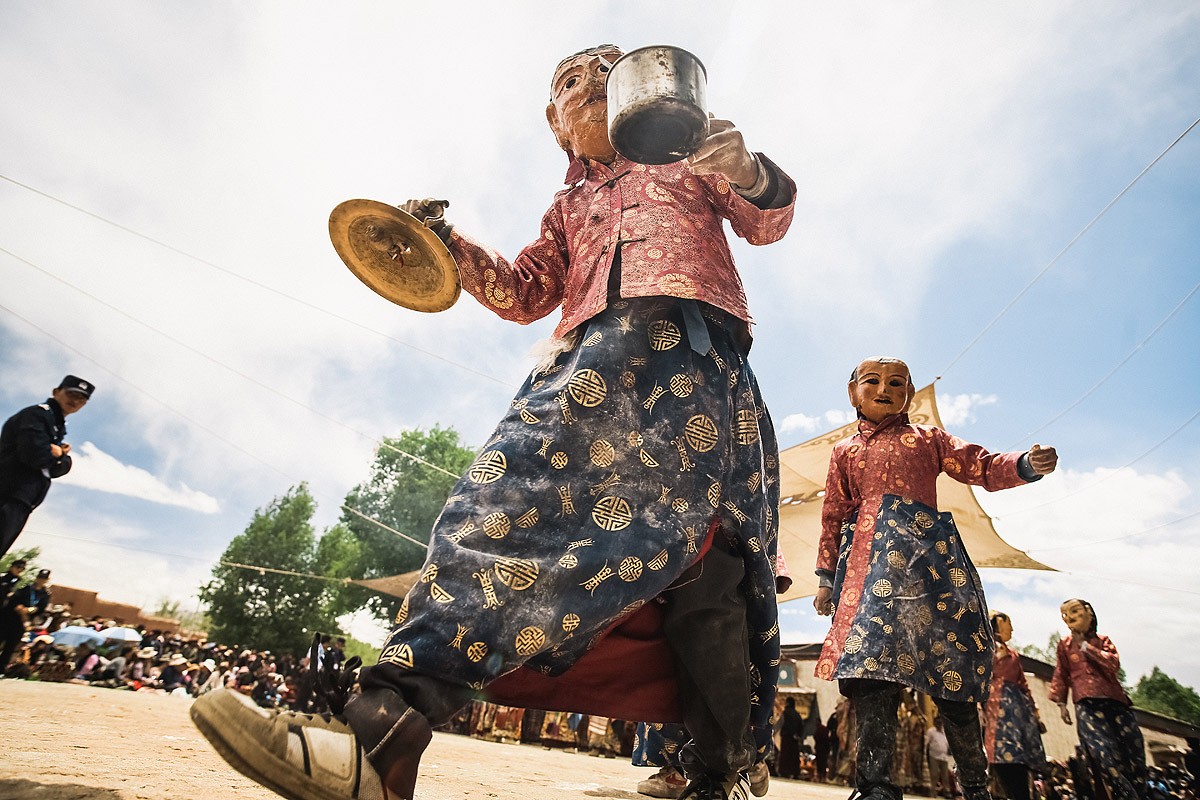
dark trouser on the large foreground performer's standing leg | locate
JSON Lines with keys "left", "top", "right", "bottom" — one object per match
{"left": 662, "top": 531, "right": 756, "bottom": 777}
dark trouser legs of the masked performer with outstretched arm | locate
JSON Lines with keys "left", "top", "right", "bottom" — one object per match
{"left": 841, "top": 679, "right": 990, "bottom": 800}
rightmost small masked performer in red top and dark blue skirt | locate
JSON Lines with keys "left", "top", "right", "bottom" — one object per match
{"left": 1050, "top": 599, "right": 1146, "bottom": 800}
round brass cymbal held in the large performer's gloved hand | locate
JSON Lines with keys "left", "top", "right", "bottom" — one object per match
{"left": 329, "top": 200, "right": 462, "bottom": 312}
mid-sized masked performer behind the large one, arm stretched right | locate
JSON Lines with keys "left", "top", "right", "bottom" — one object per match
{"left": 812, "top": 357, "right": 1058, "bottom": 800}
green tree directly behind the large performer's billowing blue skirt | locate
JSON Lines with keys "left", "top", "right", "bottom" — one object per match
{"left": 336, "top": 426, "right": 475, "bottom": 621}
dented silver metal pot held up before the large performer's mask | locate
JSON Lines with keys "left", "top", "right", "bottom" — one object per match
{"left": 607, "top": 44, "right": 708, "bottom": 164}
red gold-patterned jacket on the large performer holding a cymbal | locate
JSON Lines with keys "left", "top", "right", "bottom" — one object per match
{"left": 450, "top": 155, "right": 796, "bottom": 336}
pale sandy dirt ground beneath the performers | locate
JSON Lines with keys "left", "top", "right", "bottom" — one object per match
{"left": 0, "top": 680, "right": 850, "bottom": 800}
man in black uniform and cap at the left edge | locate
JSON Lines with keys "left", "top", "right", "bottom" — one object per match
{"left": 0, "top": 375, "right": 96, "bottom": 557}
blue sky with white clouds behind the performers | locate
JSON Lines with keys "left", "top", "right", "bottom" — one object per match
{"left": 0, "top": 0, "right": 1200, "bottom": 685}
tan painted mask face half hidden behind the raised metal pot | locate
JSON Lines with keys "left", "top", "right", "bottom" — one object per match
{"left": 546, "top": 48, "right": 622, "bottom": 163}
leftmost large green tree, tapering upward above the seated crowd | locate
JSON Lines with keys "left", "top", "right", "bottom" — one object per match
{"left": 199, "top": 483, "right": 335, "bottom": 652}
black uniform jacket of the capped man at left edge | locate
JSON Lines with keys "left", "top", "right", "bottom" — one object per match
{"left": 0, "top": 398, "right": 71, "bottom": 507}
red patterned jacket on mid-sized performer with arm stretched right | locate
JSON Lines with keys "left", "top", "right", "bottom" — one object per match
{"left": 817, "top": 414, "right": 1026, "bottom": 573}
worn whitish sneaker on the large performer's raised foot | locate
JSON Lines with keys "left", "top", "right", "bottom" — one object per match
{"left": 192, "top": 690, "right": 388, "bottom": 800}
